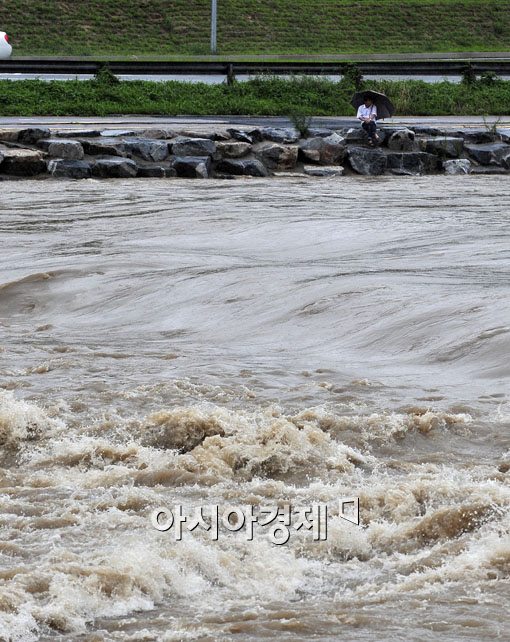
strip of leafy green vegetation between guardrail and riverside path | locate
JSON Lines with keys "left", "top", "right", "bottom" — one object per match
{"left": 0, "top": 74, "right": 510, "bottom": 117}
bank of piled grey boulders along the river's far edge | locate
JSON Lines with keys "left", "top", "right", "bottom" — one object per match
{"left": 0, "top": 122, "right": 510, "bottom": 180}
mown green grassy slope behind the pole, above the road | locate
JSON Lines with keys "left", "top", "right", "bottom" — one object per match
{"left": 0, "top": 0, "right": 510, "bottom": 57}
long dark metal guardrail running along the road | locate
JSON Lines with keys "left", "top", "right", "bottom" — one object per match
{"left": 0, "top": 58, "right": 510, "bottom": 76}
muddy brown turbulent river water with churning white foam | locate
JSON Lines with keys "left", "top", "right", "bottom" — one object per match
{"left": 0, "top": 176, "right": 510, "bottom": 642}
